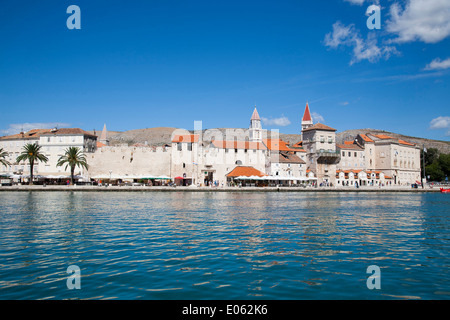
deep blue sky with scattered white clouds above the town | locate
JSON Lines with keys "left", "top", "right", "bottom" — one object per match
{"left": 0, "top": 0, "right": 450, "bottom": 141}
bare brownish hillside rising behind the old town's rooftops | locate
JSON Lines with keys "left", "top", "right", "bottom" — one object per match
{"left": 92, "top": 127, "right": 450, "bottom": 153}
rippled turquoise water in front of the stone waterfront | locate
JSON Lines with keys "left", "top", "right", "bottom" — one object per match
{"left": 0, "top": 192, "right": 450, "bottom": 299}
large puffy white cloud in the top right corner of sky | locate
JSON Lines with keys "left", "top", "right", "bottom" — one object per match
{"left": 387, "top": 0, "right": 450, "bottom": 43}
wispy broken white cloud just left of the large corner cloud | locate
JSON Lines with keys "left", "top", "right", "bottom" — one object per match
{"left": 324, "top": 21, "right": 398, "bottom": 65}
